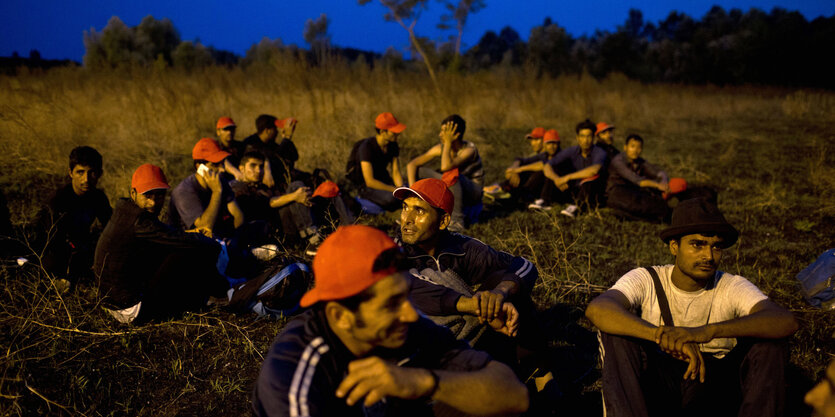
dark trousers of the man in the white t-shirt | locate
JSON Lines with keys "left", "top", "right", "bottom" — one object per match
{"left": 600, "top": 332, "right": 788, "bottom": 417}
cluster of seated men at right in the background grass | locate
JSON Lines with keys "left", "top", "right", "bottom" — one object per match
{"left": 500, "top": 119, "right": 686, "bottom": 222}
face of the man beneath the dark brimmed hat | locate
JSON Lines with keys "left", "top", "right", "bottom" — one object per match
{"left": 670, "top": 234, "right": 723, "bottom": 281}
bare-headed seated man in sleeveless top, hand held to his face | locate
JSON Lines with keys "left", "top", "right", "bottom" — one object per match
{"left": 406, "top": 114, "right": 484, "bottom": 232}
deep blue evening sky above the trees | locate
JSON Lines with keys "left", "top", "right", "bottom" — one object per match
{"left": 0, "top": 0, "right": 835, "bottom": 61}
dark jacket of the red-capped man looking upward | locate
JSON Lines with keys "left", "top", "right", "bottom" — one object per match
{"left": 397, "top": 230, "right": 539, "bottom": 305}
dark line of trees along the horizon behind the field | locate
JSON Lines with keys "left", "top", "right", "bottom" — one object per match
{"left": 75, "top": 6, "right": 835, "bottom": 89}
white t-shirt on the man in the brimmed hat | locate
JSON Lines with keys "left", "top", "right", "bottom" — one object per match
{"left": 612, "top": 265, "right": 768, "bottom": 358}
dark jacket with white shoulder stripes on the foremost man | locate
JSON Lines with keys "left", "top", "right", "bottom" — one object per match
{"left": 252, "top": 308, "right": 491, "bottom": 417}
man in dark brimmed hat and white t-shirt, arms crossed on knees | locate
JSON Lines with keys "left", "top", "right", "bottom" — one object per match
{"left": 586, "top": 199, "right": 798, "bottom": 416}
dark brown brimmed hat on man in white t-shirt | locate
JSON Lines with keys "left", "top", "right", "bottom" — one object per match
{"left": 659, "top": 198, "right": 739, "bottom": 248}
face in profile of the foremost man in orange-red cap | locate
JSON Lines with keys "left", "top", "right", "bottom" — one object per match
{"left": 350, "top": 272, "right": 418, "bottom": 349}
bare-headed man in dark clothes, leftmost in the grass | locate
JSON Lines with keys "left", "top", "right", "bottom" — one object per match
{"left": 37, "top": 146, "right": 113, "bottom": 292}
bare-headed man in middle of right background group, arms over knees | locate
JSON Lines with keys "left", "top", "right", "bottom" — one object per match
{"left": 542, "top": 119, "right": 606, "bottom": 217}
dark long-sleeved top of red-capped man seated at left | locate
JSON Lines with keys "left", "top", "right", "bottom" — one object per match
{"left": 93, "top": 198, "right": 220, "bottom": 309}
